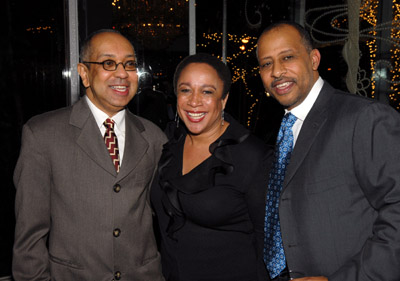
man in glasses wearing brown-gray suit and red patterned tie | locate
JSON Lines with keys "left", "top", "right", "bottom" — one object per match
{"left": 13, "top": 30, "right": 166, "bottom": 281}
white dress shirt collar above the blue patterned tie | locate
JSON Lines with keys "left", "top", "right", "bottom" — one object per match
{"left": 285, "top": 77, "right": 324, "bottom": 147}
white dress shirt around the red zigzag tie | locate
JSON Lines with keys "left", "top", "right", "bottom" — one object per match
{"left": 85, "top": 95, "right": 125, "bottom": 163}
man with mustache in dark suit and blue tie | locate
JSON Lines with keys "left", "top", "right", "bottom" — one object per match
{"left": 255, "top": 22, "right": 400, "bottom": 281}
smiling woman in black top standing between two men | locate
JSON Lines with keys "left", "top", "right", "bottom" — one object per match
{"left": 151, "top": 54, "right": 271, "bottom": 281}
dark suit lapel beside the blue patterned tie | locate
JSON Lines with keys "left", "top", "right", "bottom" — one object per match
{"left": 283, "top": 81, "right": 334, "bottom": 190}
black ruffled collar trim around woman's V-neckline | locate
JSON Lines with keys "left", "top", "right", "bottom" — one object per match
{"left": 158, "top": 114, "right": 250, "bottom": 237}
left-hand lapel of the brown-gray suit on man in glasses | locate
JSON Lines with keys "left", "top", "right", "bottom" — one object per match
{"left": 70, "top": 99, "right": 117, "bottom": 176}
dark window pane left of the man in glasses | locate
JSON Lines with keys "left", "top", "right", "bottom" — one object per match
{"left": 0, "top": 0, "right": 67, "bottom": 277}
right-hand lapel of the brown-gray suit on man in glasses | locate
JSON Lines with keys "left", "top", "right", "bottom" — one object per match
{"left": 118, "top": 110, "right": 149, "bottom": 179}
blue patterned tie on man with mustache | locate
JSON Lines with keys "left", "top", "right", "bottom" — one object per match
{"left": 264, "top": 113, "right": 297, "bottom": 279}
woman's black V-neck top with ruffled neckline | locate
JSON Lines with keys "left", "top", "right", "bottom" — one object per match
{"left": 151, "top": 114, "right": 267, "bottom": 281}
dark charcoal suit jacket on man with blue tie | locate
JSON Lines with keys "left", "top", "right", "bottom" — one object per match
{"left": 250, "top": 82, "right": 400, "bottom": 281}
